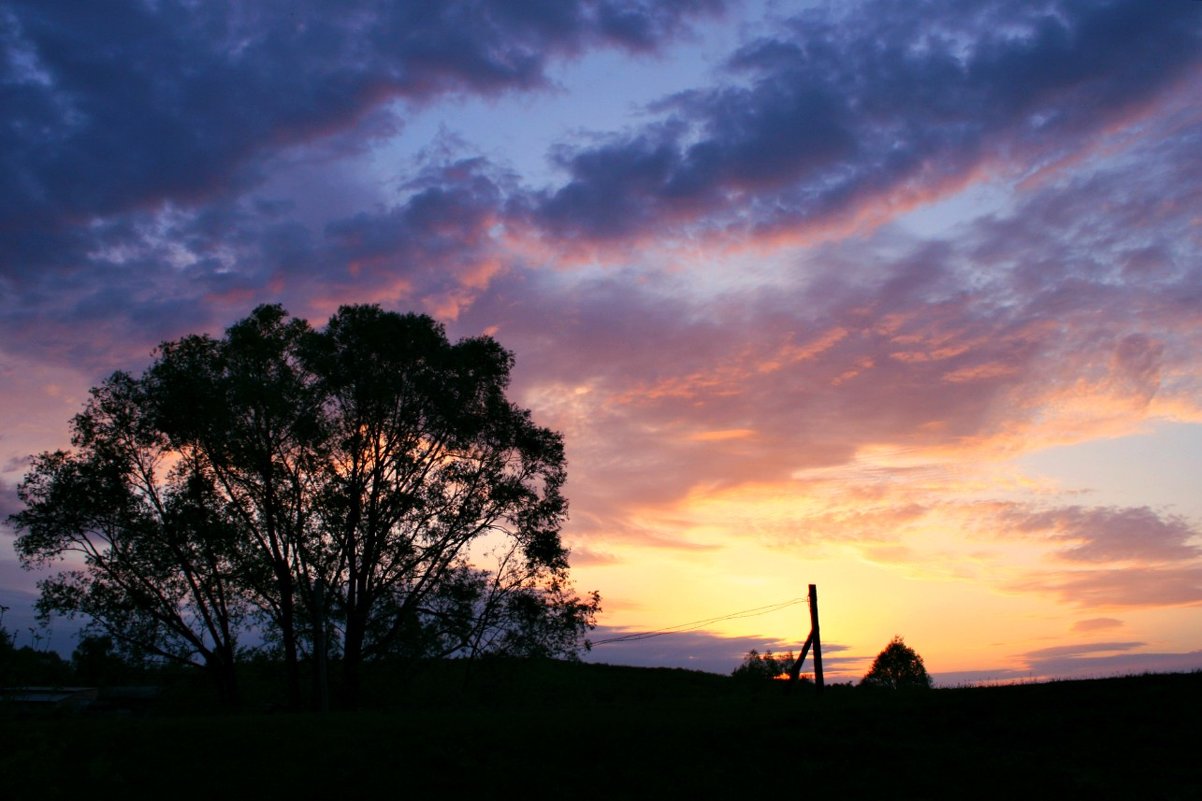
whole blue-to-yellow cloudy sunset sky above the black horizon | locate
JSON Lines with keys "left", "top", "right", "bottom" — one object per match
{"left": 0, "top": 0, "right": 1202, "bottom": 686}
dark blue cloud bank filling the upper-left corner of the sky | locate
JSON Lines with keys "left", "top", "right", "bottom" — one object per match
{"left": 0, "top": 0, "right": 721, "bottom": 230}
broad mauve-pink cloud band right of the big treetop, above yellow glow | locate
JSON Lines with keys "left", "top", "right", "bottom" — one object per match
{"left": 451, "top": 185, "right": 1202, "bottom": 524}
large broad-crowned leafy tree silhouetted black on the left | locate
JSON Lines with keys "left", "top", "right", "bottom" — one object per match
{"left": 12, "top": 305, "right": 599, "bottom": 702}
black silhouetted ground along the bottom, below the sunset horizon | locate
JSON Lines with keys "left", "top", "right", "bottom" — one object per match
{"left": 0, "top": 663, "right": 1202, "bottom": 801}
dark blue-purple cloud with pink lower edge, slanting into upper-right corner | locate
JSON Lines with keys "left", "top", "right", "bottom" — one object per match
{"left": 535, "top": 1, "right": 1202, "bottom": 239}
